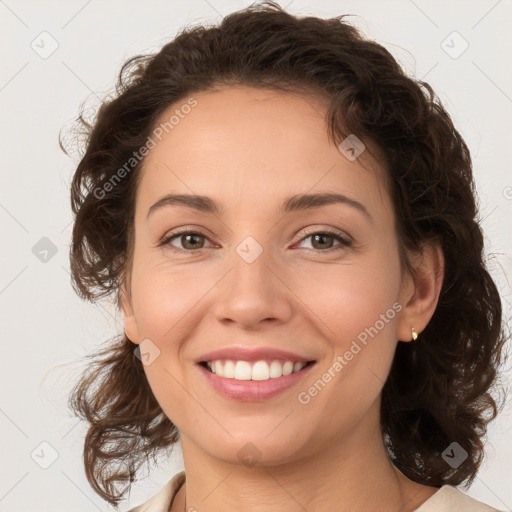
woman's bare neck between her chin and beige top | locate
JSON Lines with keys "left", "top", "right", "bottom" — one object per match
{"left": 172, "top": 406, "right": 438, "bottom": 512}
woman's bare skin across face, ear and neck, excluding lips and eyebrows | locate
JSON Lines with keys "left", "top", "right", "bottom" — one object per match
{"left": 122, "top": 86, "right": 444, "bottom": 512}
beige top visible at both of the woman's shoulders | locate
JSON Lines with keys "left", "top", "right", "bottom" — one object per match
{"left": 128, "top": 470, "right": 500, "bottom": 512}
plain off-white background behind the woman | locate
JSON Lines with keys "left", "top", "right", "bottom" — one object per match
{"left": 0, "top": 0, "right": 512, "bottom": 512}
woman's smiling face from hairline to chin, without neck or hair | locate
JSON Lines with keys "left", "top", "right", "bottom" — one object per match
{"left": 123, "top": 86, "right": 418, "bottom": 465}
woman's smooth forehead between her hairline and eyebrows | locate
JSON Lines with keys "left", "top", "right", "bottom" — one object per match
{"left": 137, "top": 86, "right": 386, "bottom": 216}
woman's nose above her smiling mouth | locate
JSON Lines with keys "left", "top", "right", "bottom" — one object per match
{"left": 214, "top": 245, "right": 293, "bottom": 330}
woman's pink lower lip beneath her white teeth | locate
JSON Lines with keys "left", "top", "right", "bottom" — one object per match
{"left": 198, "top": 363, "right": 316, "bottom": 402}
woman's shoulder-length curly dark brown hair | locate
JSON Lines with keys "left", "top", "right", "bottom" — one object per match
{"left": 64, "top": 2, "right": 508, "bottom": 507}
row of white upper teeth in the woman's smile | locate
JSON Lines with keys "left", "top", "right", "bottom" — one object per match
{"left": 206, "top": 360, "right": 306, "bottom": 380}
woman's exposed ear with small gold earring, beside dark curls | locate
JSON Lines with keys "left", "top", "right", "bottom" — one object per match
{"left": 397, "top": 243, "right": 444, "bottom": 341}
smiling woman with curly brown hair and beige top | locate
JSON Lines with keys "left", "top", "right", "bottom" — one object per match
{"left": 65, "top": 3, "right": 505, "bottom": 512}
